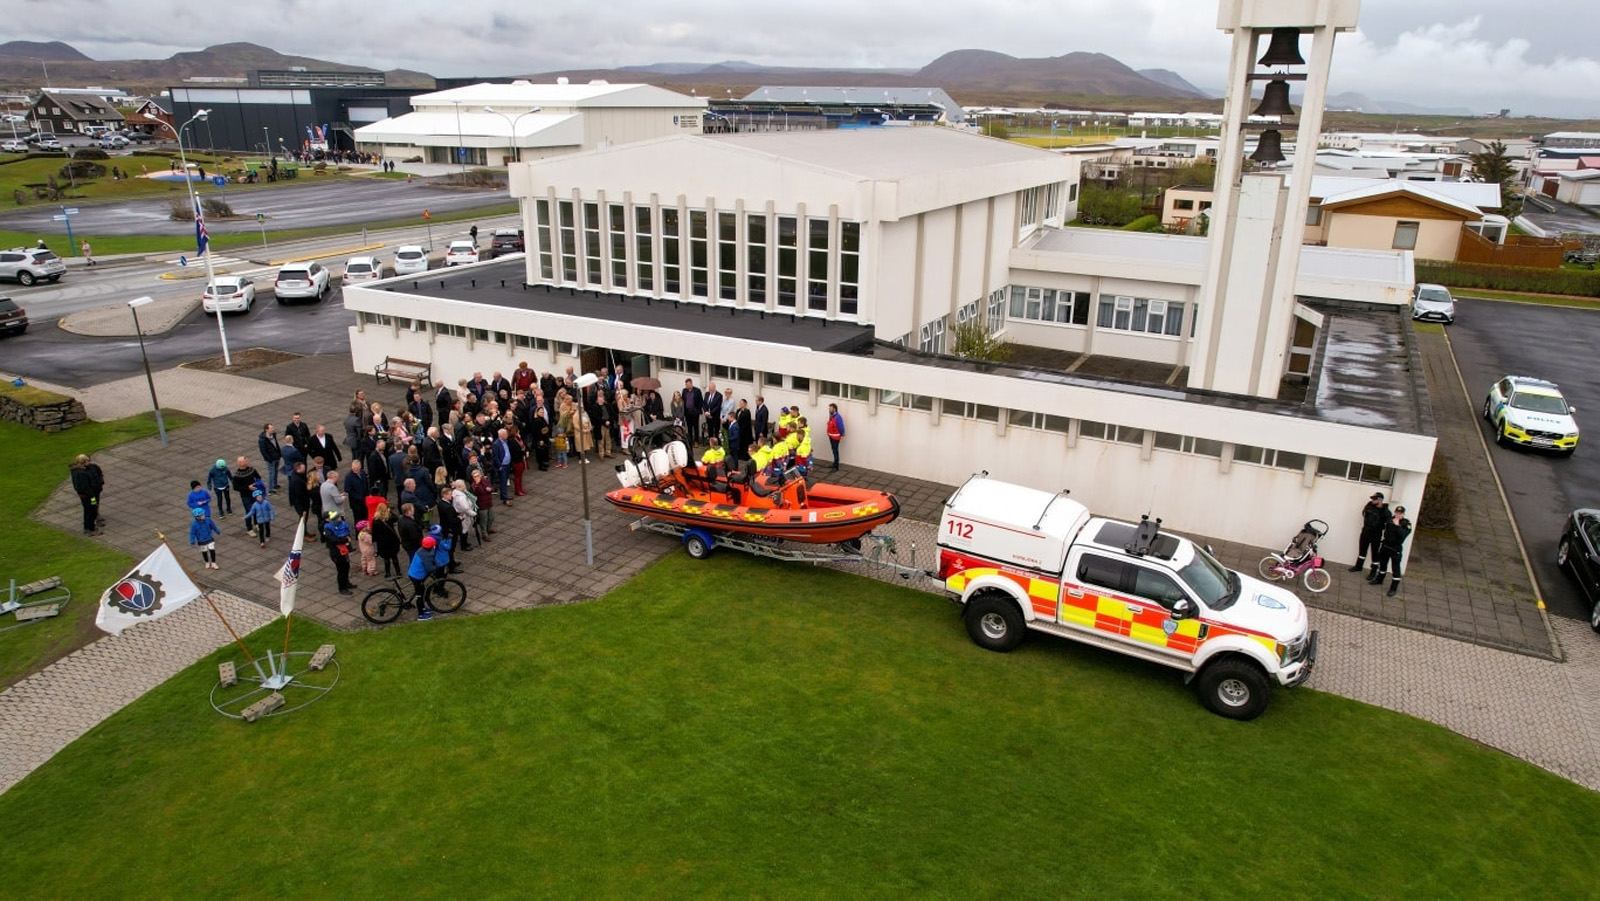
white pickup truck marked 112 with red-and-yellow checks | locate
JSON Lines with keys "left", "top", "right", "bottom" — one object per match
{"left": 939, "top": 474, "right": 1317, "bottom": 720}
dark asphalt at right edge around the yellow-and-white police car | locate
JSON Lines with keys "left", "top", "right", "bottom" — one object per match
{"left": 1448, "top": 298, "right": 1600, "bottom": 619}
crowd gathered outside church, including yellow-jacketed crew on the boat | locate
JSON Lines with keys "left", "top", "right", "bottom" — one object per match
{"left": 172, "top": 362, "right": 845, "bottom": 619}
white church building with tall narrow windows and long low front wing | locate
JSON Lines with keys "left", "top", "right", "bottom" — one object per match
{"left": 344, "top": 0, "right": 1435, "bottom": 560}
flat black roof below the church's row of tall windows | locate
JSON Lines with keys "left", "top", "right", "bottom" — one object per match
{"left": 371, "top": 258, "right": 872, "bottom": 354}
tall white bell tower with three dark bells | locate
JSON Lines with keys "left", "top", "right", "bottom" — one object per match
{"left": 1189, "top": 0, "right": 1360, "bottom": 397}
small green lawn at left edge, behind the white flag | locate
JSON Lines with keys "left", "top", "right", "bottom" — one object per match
{"left": 0, "top": 411, "right": 182, "bottom": 687}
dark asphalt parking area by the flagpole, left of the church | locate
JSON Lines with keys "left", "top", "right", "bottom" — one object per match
{"left": 0, "top": 283, "right": 355, "bottom": 387}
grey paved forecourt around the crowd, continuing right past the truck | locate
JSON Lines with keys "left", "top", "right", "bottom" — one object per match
{"left": 3, "top": 352, "right": 1600, "bottom": 791}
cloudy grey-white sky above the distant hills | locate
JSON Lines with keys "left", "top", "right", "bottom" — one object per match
{"left": 21, "top": 0, "right": 1600, "bottom": 118}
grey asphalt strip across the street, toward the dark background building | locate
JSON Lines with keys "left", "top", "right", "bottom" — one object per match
{"left": 0, "top": 176, "right": 510, "bottom": 238}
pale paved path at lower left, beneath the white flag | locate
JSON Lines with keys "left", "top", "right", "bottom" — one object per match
{"left": 0, "top": 595, "right": 277, "bottom": 792}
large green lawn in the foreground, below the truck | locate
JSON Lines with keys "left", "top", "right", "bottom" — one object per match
{"left": 0, "top": 553, "right": 1600, "bottom": 899}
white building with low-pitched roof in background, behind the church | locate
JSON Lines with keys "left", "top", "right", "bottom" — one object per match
{"left": 355, "top": 80, "right": 706, "bottom": 166}
